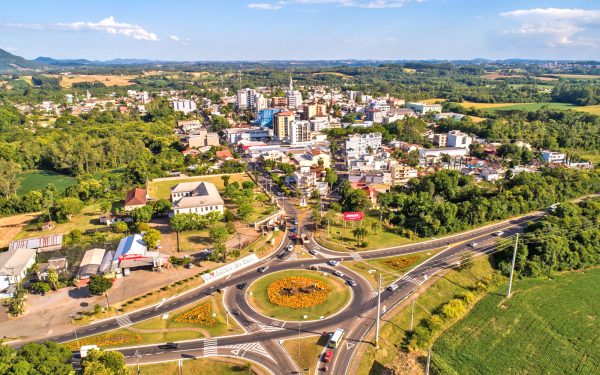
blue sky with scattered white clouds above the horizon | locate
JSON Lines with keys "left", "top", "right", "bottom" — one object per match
{"left": 0, "top": 0, "right": 600, "bottom": 61}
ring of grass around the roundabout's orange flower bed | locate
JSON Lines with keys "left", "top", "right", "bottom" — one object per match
{"left": 247, "top": 270, "right": 351, "bottom": 320}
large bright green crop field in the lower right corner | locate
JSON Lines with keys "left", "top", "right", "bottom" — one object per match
{"left": 432, "top": 269, "right": 600, "bottom": 374}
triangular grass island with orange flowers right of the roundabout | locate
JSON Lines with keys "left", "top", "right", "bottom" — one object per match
{"left": 342, "top": 249, "right": 442, "bottom": 287}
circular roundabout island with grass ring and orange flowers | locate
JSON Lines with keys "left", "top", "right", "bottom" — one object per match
{"left": 246, "top": 270, "right": 352, "bottom": 321}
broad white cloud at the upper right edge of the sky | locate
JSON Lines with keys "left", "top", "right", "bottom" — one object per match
{"left": 500, "top": 8, "right": 600, "bottom": 47}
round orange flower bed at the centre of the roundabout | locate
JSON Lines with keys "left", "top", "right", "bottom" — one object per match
{"left": 267, "top": 276, "right": 329, "bottom": 309}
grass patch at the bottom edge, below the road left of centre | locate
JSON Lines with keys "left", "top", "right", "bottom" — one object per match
{"left": 138, "top": 358, "right": 267, "bottom": 375}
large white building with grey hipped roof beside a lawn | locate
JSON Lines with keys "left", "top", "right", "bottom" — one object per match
{"left": 171, "top": 181, "right": 225, "bottom": 215}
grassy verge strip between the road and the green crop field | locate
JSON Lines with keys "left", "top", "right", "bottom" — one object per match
{"left": 355, "top": 258, "right": 493, "bottom": 375}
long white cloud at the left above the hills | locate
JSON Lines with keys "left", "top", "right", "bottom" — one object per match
{"left": 2, "top": 16, "right": 160, "bottom": 42}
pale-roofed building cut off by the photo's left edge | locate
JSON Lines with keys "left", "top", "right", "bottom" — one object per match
{"left": 0, "top": 248, "right": 37, "bottom": 298}
